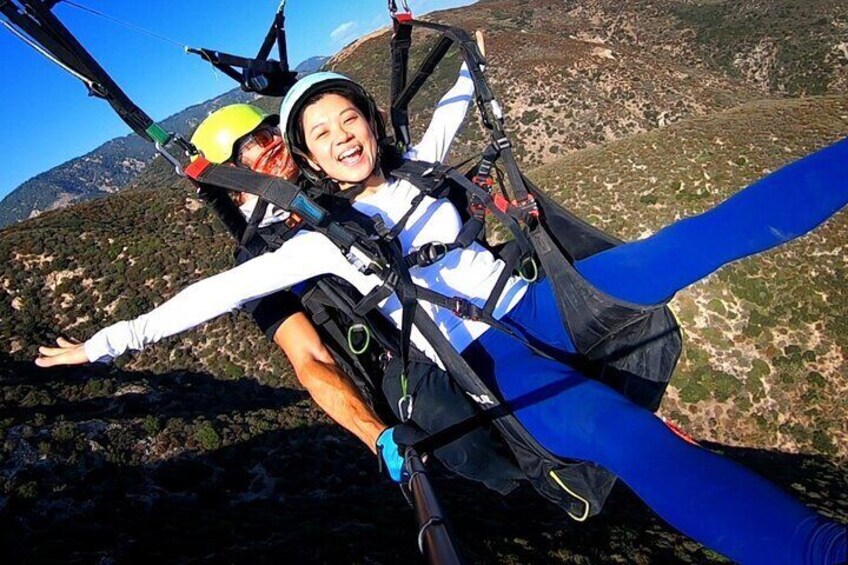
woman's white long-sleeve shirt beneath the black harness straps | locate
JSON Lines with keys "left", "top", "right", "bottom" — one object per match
{"left": 85, "top": 67, "right": 526, "bottom": 365}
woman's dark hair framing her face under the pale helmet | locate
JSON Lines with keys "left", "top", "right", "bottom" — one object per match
{"left": 289, "top": 80, "right": 403, "bottom": 185}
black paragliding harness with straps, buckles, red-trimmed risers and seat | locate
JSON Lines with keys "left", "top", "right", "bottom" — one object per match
{"left": 0, "top": 0, "right": 682, "bottom": 552}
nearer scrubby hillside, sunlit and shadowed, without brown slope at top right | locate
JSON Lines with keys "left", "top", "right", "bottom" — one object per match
{"left": 0, "top": 97, "right": 848, "bottom": 563}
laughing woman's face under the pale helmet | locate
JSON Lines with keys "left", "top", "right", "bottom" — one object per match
{"left": 301, "top": 94, "right": 377, "bottom": 188}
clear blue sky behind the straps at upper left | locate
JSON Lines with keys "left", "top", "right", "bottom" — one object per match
{"left": 0, "top": 0, "right": 473, "bottom": 198}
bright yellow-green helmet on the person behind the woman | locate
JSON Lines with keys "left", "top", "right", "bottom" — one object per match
{"left": 191, "top": 104, "right": 280, "bottom": 164}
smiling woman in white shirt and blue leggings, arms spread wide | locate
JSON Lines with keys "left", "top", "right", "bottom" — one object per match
{"left": 19, "top": 2, "right": 848, "bottom": 564}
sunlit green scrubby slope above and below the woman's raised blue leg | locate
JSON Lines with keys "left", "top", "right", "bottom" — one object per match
{"left": 531, "top": 92, "right": 848, "bottom": 459}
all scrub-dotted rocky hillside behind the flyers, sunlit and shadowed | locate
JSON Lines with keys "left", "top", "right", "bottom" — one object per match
{"left": 0, "top": 0, "right": 848, "bottom": 564}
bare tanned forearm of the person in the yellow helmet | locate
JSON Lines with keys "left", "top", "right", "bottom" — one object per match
{"left": 274, "top": 313, "right": 386, "bottom": 452}
